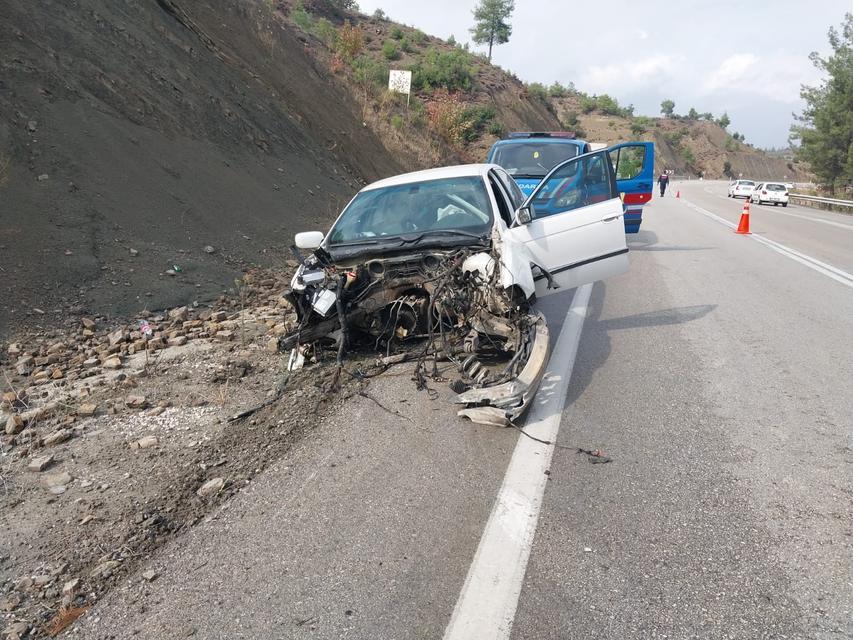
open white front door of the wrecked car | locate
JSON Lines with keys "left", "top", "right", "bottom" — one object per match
{"left": 506, "top": 149, "right": 628, "bottom": 297}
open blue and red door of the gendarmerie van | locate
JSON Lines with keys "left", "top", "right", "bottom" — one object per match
{"left": 608, "top": 142, "right": 655, "bottom": 233}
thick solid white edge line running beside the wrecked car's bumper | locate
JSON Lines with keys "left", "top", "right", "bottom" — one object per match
{"left": 444, "top": 284, "right": 592, "bottom": 640}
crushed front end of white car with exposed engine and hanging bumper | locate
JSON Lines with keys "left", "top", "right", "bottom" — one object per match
{"left": 280, "top": 248, "right": 548, "bottom": 425}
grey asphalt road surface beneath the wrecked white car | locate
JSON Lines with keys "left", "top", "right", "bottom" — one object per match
{"left": 71, "top": 183, "right": 853, "bottom": 640}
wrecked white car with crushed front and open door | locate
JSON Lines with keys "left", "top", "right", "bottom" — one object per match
{"left": 280, "top": 149, "right": 628, "bottom": 425}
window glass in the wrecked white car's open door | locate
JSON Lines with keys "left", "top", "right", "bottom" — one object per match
{"left": 533, "top": 150, "right": 617, "bottom": 218}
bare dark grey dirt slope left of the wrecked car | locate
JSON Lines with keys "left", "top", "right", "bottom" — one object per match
{"left": 0, "top": 0, "right": 400, "bottom": 334}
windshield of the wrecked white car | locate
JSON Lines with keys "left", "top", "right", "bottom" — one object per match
{"left": 328, "top": 176, "right": 493, "bottom": 246}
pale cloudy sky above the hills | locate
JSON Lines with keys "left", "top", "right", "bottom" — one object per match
{"left": 352, "top": 0, "right": 853, "bottom": 148}
